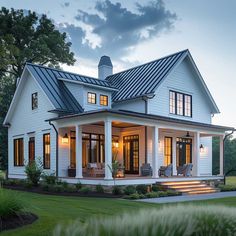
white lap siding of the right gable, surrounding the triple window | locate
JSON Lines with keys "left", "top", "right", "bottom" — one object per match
{"left": 148, "top": 59, "right": 211, "bottom": 123}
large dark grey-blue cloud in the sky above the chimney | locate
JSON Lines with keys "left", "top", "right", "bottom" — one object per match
{"left": 59, "top": 0, "right": 177, "bottom": 59}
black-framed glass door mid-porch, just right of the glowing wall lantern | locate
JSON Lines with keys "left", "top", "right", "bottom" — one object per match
{"left": 123, "top": 135, "right": 139, "bottom": 174}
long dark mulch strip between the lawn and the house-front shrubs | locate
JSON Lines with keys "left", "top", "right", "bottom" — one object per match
{"left": 3, "top": 185, "right": 123, "bottom": 198}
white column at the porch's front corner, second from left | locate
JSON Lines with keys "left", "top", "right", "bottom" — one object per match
{"left": 104, "top": 120, "right": 113, "bottom": 180}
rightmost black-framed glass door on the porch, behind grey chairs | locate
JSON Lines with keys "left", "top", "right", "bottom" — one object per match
{"left": 176, "top": 138, "right": 192, "bottom": 167}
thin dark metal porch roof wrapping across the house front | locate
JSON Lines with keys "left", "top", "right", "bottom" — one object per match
{"left": 46, "top": 109, "right": 236, "bottom": 131}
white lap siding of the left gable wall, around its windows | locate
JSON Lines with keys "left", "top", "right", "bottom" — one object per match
{"left": 8, "top": 75, "right": 56, "bottom": 178}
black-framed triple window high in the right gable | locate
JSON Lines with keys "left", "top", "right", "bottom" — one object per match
{"left": 169, "top": 91, "right": 192, "bottom": 117}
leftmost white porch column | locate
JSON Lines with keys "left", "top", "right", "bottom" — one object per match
{"left": 75, "top": 125, "right": 83, "bottom": 179}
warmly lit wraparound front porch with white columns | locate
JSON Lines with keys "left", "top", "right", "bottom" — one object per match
{"left": 51, "top": 109, "right": 224, "bottom": 185}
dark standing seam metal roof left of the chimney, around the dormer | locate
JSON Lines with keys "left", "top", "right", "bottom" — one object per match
{"left": 26, "top": 63, "right": 114, "bottom": 113}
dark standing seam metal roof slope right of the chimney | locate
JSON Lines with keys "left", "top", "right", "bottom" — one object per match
{"left": 106, "top": 50, "right": 188, "bottom": 102}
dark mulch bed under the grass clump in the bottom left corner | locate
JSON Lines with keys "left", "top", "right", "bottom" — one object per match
{"left": 0, "top": 213, "right": 38, "bottom": 232}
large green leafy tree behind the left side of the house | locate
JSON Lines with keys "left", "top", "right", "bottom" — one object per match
{"left": 0, "top": 7, "right": 75, "bottom": 169}
